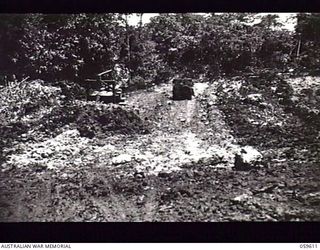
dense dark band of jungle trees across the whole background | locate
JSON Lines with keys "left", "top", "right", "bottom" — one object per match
{"left": 0, "top": 13, "right": 320, "bottom": 88}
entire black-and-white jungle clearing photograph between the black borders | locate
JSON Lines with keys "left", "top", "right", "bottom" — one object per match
{"left": 0, "top": 12, "right": 320, "bottom": 222}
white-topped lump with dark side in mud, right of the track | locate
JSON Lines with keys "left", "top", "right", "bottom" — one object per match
{"left": 234, "top": 146, "right": 262, "bottom": 170}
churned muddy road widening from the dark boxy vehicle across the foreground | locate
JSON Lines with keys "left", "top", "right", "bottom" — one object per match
{"left": 0, "top": 77, "right": 320, "bottom": 222}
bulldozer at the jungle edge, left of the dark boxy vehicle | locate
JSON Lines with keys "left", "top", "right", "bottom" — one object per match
{"left": 85, "top": 69, "right": 126, "bottom": 105}
